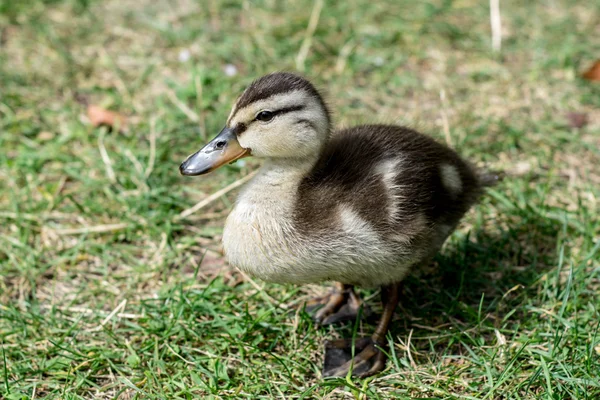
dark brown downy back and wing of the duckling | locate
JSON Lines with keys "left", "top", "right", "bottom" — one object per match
{"left": 295, "top": 125, "right": 480, "bottom": 234}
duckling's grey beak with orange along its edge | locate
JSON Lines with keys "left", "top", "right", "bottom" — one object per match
{"left": 179, "top": 127, "right": 250, "bottom": 176}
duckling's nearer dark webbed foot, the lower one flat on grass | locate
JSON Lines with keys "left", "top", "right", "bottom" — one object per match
{"left": 323, "top": 338, "right": 386, "bottom": 378}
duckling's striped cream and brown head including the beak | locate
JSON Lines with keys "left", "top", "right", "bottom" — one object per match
{"left": 179, "top": 72, "right": 330, "bottom": 175}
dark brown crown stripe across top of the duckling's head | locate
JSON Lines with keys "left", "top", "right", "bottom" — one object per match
{"left": 232, "top": 72, "right": 330, "bottom": 121}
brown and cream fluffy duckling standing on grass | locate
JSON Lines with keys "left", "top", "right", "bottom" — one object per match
{"left": 180, "top": 72, "right": 484, "bottom": 377}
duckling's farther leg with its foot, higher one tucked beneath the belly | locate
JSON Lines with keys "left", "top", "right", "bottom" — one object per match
{"left": 306, "top": 282, "right": 368, "bottom": 325}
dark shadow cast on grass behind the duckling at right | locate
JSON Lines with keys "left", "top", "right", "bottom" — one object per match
{"left": 390, "top": 211, "right": 562, "bottom": 354}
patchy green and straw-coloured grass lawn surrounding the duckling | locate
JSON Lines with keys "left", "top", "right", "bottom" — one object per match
{"left": 0, "top": 0, "right": 600, "bottom": 399}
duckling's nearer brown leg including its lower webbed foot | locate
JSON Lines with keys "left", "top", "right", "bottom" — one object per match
{"left": 323, "top": 284, "right": 399, "bottom": 378}
